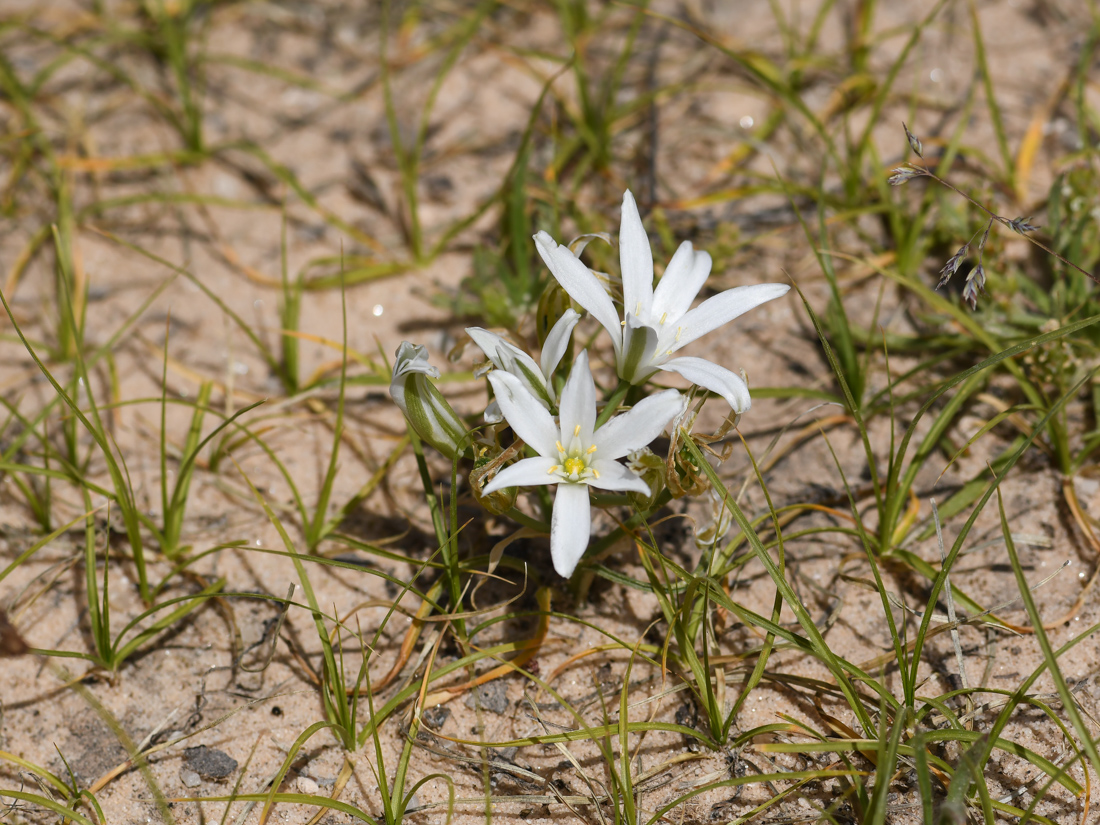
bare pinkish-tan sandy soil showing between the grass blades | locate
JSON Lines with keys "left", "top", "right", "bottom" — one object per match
{"left": 0, "top": 0, "right": 1100, "bottom": 823}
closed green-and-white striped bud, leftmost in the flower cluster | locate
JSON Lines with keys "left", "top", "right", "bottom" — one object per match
{"left": 389, "top": 341, "right": 466, "bottom": 460}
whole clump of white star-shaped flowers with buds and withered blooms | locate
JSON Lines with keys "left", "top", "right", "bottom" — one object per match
{"left": 391, "top": 191, "right": 789, "bottom": 579}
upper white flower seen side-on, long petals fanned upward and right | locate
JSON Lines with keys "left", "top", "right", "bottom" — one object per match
{"left": 535, "top": 190, "right": 790, "bottom": 414}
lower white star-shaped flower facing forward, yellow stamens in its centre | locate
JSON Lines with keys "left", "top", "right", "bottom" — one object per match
{"left": 484, "top": 351, "right": 684, "bottom": 579}
